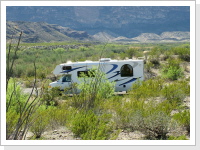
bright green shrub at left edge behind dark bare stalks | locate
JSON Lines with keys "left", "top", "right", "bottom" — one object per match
{"left": 6, "top": 78, "right": 39, "bottom": 140}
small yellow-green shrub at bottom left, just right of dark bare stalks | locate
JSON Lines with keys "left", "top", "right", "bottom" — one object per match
{"left": 30, "top": 106, "right": 49, "bottom": 138}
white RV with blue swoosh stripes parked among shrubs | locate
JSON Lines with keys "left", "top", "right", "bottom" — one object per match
{"left": 50, "top": 58, "right": 144, "bottom": 92}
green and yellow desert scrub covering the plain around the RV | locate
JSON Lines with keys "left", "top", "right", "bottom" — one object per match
{"left": 6, "top": 37, "right": 190, "bottom": 140}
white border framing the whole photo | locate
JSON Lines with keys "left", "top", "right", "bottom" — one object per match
{"left": 1, "top": 1, "right": 196, "bottom": 145}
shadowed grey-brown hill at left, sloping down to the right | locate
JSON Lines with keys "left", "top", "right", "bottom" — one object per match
{"left": 6, "top": 21, "right": 93, "bottom": 43}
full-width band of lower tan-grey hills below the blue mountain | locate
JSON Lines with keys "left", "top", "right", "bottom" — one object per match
{"left": 6, "top": 21, "right": 190, "bottom": 43}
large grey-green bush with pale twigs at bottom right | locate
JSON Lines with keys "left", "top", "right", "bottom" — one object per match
{"left": 127, "top": 100, "right": 171, "bottom": 139}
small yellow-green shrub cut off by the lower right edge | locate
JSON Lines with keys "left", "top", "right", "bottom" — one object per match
{"left": 173, "top": 110, "right": 190, "bottom": 134}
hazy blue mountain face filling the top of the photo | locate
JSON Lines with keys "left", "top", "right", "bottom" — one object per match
{"left": 6, "top": 6, "right": 190, "bottom": 38}
